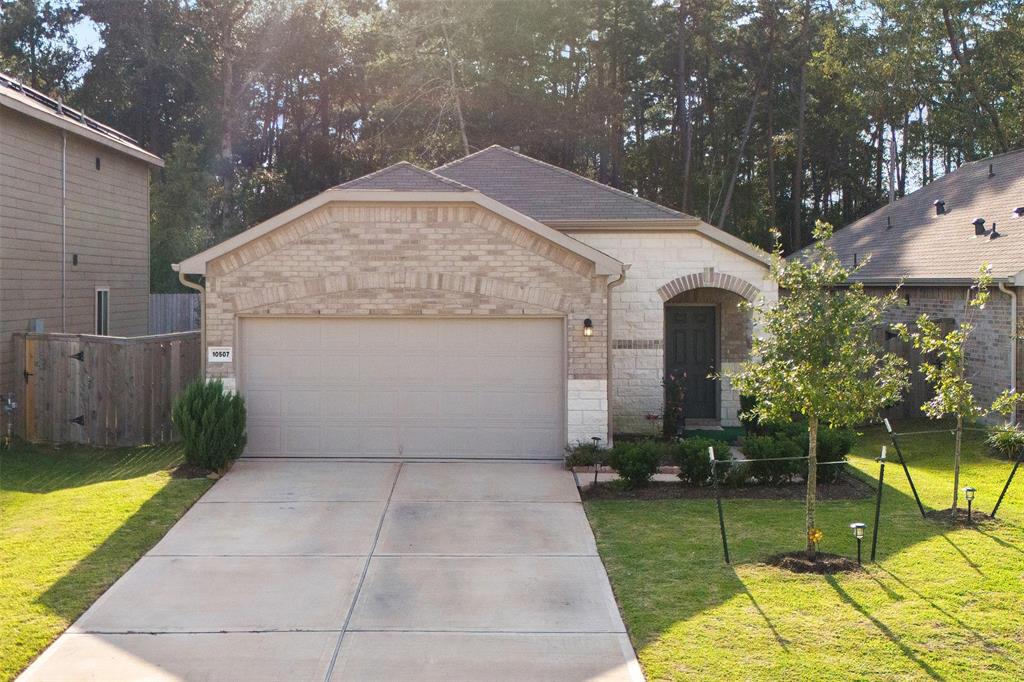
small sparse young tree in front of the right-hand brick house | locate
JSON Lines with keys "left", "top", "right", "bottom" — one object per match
{"left": 895, "top": 265, "right": 999, "bottom": 514}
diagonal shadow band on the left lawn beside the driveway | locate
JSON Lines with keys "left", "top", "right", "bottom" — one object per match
{"left": 36, "top": 480, "right": 208, "bottom": 623}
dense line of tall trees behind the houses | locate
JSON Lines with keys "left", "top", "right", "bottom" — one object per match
{"left": 0, "top": 0, "right": 1024, "bottom": 290}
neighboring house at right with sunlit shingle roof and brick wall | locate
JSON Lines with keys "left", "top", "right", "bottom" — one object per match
{"left": 802, "top": 150, "right": 1024, "bottom": 417}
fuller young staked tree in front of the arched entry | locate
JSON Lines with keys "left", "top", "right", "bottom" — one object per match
{"left": 730, "top": 221, "right": 909, "bottom": 556}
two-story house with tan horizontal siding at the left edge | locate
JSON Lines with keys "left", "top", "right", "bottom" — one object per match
{"left": 0, "top": 74, "right": 163, "bottom": 392}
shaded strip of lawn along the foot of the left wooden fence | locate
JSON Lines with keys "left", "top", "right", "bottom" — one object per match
{"left": 0, "top": 444, "right": 181, "bottom": 493}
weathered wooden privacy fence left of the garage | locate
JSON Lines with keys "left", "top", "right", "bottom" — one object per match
{"left": 14, "top": 332, "right": 203, "bottom": 445}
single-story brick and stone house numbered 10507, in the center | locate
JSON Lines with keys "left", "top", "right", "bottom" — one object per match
{"left": 175, "top": 146, "right": 776, "bottom": 458}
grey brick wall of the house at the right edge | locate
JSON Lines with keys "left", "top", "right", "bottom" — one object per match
{"left": 866, "top": 280, "right": 1024, "bottom": 421}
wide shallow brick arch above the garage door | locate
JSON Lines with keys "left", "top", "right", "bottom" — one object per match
{"left": 234, "top": 269, "right": 571, "bottom": 312}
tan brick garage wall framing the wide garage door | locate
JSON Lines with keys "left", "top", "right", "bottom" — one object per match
{"left": 206, "top": 204, "right": 607, "bottom": 439}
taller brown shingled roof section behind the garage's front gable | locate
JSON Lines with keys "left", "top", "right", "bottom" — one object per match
{"left": 433, "top": 144, "right": 689, "bottom": 222}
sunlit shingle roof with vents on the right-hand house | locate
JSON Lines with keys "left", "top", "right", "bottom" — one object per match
{"left": 815, "top": 150, "right": 1024, "bottom": 284}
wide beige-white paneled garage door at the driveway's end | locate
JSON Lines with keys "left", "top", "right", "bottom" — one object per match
{"left": 239, "top": 317, "right": 565, "bottom": 459}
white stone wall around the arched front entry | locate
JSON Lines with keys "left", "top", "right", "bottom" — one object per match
{"left": 568, "top": 230, "right": 777, "bottom": 433}
